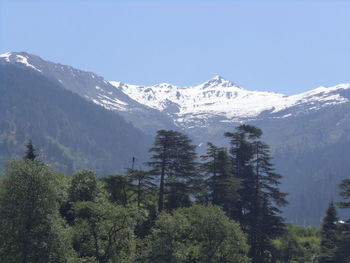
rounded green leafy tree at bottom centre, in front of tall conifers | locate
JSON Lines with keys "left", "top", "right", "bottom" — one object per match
{"left": 143, "top": 205, "right": 249, "bottom": 263}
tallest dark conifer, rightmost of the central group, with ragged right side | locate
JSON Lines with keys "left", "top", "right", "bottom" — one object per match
{"left": 225, "top": 125, "right": 287, "bottom": 263}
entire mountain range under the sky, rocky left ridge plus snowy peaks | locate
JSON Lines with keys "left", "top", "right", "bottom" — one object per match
{"left": 0, "top": 52, "right": 350, "bottom": 132}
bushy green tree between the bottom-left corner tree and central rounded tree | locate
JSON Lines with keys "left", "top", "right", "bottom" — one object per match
{"left": 72, "top": 201, "right": 135, "bottom": 263}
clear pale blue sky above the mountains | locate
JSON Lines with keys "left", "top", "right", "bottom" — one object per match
{"left": 0, "top": 0, "right": 350, "bottom": 95}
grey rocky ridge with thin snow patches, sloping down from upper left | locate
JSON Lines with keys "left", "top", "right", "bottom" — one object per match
{"left": 0, "top": 52, "right": 176, "bottom": 135}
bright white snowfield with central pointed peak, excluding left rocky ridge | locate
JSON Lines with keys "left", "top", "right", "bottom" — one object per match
{"left": 110, "top": 76, "right": 350, "bottom": 128}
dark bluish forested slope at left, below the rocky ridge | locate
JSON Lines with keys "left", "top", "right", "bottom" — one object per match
{"left": 0, "top": 64, "right": 151, "bottom": 175}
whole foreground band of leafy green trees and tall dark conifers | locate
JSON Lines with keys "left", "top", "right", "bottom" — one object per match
{"left": 0, "top": 125, "right": 350, "bottom": 263}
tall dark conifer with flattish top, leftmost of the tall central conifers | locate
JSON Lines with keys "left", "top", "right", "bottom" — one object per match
{"left": 148, "top": 130, "right": 197, "bottom": 211}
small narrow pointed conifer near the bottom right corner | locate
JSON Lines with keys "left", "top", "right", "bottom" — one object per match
{"left": 318, "top": 202, "right": 339, "bottom": 263}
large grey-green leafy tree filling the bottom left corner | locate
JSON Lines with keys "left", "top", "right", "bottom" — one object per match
{"left": 0, "top": 160, "right": 69, "bottom": 263}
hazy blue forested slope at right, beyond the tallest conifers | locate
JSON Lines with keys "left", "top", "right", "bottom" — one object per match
{"left": 254, "top": 106, "right": 350, "bottom": 226}
